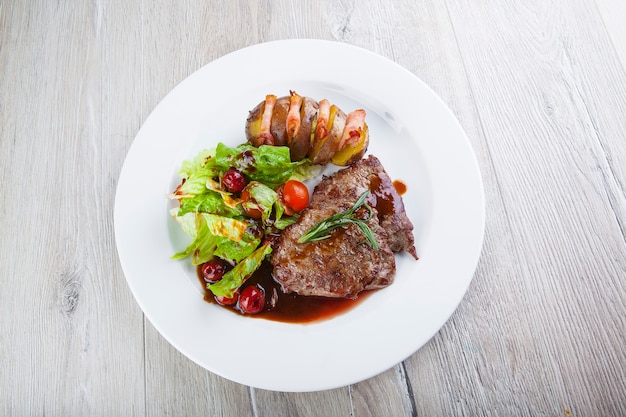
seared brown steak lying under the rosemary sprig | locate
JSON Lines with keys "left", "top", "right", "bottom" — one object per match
{"left": 270, "top": 155, "right": 417, "bottom": 298}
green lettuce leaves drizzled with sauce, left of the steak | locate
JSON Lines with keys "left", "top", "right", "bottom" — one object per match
{"left": 169, "top": 143, "right": 320, "bottom": 296}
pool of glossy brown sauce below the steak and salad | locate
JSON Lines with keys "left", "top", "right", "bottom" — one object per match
{"left": 197, "top": 262, "right": 372, "bottom": 324}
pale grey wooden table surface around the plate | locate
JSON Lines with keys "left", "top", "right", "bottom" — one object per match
{"left": 0, "top": 0, "right": 626, "bottom": 417}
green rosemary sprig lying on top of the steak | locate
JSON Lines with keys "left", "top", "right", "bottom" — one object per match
{"left": 298, "top": 190, "right": 380, "bottom": 250}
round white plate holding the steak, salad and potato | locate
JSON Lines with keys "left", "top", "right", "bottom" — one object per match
{"left": 114, "top": 40, "right": 484, "bottom": 391}
